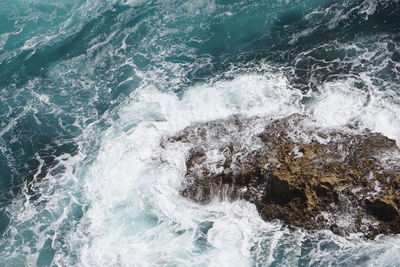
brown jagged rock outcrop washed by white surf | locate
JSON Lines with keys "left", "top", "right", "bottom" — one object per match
{"left": 163, "top": 115, "right": 400, "bottom": 238}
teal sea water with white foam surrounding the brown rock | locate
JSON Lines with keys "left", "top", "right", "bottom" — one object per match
{"left": 0, "top": 0, "right": 400, "bottom": 266}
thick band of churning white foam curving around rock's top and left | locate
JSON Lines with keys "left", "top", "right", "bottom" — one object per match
{"left": 73, "top": 70, "right": 398, "bottom": 266}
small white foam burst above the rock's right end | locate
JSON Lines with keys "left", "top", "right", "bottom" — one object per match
{"left": 306, "top": 79, "right": 400, "bottom": 144}
